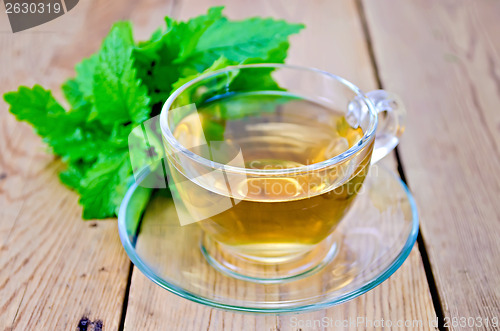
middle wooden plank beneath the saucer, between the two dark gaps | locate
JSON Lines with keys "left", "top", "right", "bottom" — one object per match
{"left": 125, "top": 0, "right": 435, "bottom": 331}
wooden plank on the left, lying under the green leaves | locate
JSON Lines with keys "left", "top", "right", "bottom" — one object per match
{"left": 0, "top": 0, "right": 172, "bottom": 330}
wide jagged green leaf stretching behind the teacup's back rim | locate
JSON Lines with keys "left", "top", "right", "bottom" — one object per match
{"left": 134, "top": 7, "right": 303, "bottom": 104}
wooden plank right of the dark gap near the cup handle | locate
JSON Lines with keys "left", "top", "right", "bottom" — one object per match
{"left": 364, "top": 0, "right": 500, "bottom": 329}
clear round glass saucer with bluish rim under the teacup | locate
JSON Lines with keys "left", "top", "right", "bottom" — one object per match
{"left": 118, "top": 165, "right": 418, "bottom": 313}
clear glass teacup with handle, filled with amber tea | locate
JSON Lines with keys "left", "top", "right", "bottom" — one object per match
{"left": 160, "top": 64, "right": 404, "bottom": 281}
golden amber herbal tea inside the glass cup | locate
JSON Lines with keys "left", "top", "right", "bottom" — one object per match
{"left": 169, "top": 92, "right": 372, "bottom": 261}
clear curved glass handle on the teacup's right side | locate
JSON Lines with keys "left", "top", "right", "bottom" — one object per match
{"left": 366, "top": 90, "right": 406, "bottom": 164}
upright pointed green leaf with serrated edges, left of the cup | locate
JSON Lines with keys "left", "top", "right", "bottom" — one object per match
{"left": 92, "top": 22, "right": 150, "bottom": 125}
